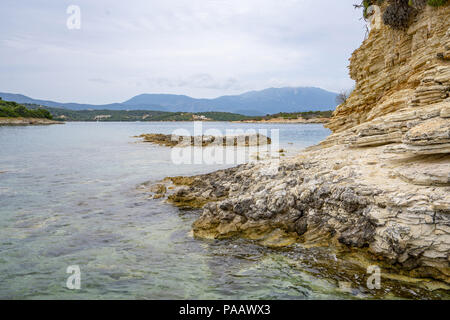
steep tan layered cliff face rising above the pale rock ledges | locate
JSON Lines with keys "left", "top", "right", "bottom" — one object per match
{"left": 327, "top": 5, "right": 450, "bottom": 132}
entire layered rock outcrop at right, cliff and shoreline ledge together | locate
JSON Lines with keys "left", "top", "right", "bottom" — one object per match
{"left": 144, "top": 5, "right": 450, "bottom": 284}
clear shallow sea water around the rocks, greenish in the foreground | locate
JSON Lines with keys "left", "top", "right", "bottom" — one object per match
{"left": 0, "top": 123, "right": 446, "bottom": 299}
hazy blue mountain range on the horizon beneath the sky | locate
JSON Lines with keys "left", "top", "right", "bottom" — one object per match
{"left": 0, "top": 87, "right": 337, "bottom": 116}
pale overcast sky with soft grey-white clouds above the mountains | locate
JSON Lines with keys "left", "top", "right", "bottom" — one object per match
{"left": 0, "top": 0, "right": 366, "bottom": 104}
